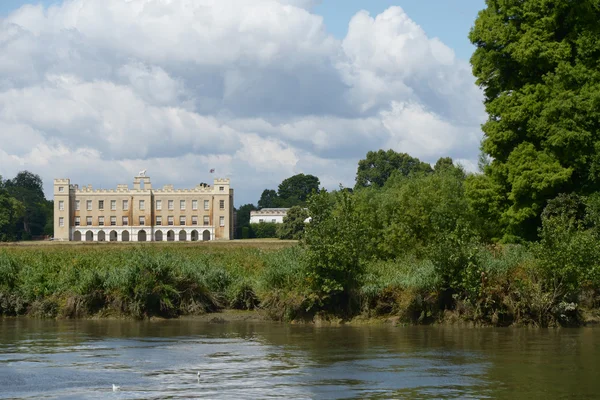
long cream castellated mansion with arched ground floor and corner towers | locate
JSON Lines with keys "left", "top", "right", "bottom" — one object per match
{"left": 54, "top": 173, "right": 234, "bottom": 242}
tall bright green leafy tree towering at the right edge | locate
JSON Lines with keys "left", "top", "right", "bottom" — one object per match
{"left": 470, "top": 0, "right": 600, "bottom": 239}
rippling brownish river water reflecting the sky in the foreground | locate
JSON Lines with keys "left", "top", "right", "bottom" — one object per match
{"left": 0, "top": 319, "right": 600, "bottom": 400}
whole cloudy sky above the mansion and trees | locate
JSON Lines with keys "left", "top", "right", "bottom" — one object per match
{"left": 0, "top": 0, "right": 486, "bottom": 206}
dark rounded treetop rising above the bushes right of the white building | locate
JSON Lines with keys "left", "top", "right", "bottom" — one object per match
{"left": 355, "top": 149, "right": 432, "bottom": 188}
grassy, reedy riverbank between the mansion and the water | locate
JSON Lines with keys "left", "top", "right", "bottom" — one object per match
{"left": 0, "top": 240, "right": 600, "bottom": 326}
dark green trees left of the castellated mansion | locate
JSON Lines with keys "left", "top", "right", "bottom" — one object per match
{"left": 0, "top": 171, "right": 54, "bottom": 242}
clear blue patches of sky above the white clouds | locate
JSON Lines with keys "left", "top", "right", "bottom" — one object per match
{"left": 0, "top": 0, "right": 485, "bottom": 60}
